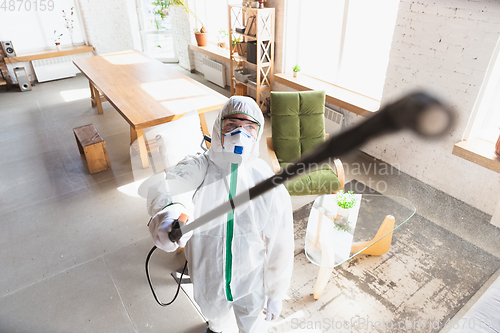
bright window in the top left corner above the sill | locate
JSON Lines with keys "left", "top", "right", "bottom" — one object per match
{"left": 0, "top": 0, "right": 85, "bottom": 53}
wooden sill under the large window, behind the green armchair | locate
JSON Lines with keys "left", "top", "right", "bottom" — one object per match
{"left": 274, "top": 73, "right": 380, "bottom": 117}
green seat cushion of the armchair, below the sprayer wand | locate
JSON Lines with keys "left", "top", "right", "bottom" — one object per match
{"left": 280, "top": 163, "right": 340, "bottom": 195}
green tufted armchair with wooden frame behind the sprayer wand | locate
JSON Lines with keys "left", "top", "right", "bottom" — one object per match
{"left": 267, "top": 91, "right": 345, "bottom": 195}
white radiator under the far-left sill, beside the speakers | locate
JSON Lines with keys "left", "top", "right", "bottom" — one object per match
{"left": 31, "top": 56, "right": 80, "bottom": 82}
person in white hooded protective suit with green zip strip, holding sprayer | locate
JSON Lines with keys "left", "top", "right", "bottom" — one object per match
{"left": 148, "top": 96, "right": 294, "bottom": 333}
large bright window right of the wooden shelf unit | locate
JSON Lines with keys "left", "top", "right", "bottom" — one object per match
{"left": 285, "top": 0, "right": 399, "bottom": 100}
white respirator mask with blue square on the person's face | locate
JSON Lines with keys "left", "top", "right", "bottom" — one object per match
{"left": 222, "top": 127, "right": 255, "bottom": 164}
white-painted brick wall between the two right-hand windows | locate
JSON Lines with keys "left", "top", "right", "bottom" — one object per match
{"left": 364, "top": 0, "right": 500, "bottom": 220}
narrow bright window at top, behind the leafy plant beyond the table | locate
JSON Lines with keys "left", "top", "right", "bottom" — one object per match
{"left": 139, "top": 0, "right": 178, "bottom": 62}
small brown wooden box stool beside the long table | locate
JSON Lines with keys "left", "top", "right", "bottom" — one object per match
{"left": 73, "top": 124, "right": 111, "bottom": 174}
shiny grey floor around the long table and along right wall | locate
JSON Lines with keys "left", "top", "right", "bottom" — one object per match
{"left": 0, "top": 65, "right": 500, "bottom": 333}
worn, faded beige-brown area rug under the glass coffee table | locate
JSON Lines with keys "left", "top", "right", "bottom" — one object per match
{"left": 269, "top": 181, "right": 500, "bottom": 333}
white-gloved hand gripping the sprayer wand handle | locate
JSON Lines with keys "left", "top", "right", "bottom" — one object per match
{"left": 149, "top": 204, "right": 193, "bottom": 252}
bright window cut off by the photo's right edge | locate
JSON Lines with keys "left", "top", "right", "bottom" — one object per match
{"left": 464, "top": 38, "right": 500, "bottom": 143}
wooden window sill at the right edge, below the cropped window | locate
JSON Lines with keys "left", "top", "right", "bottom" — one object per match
{"left": 452, "top": 138, "right": 500, "bottom": 173}
